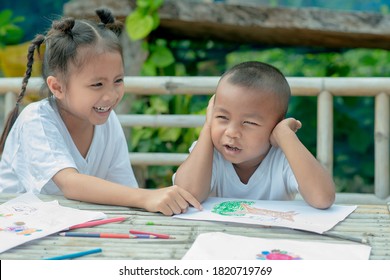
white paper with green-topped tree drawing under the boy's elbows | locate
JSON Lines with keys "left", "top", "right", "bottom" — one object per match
{"left": 174, "top": 197, "right": 356, "bottom": 233}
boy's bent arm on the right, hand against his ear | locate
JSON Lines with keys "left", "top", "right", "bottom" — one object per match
{"left": 271, "top": 118, "right": 335, "bottom": 209}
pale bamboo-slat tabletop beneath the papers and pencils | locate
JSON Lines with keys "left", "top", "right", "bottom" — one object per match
{"left": 0, "top": 194, "right": 390, "bottom": 260}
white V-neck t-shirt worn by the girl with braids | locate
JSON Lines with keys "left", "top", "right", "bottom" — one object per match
{"left": 0, "top": 99, "right": 138, "bottom": 194}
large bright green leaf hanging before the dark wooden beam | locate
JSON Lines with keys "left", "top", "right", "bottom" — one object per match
{"left": 125, "top": 11, "right": 153, "bottom": 40}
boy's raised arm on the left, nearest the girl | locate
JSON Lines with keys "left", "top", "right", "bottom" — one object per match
{"left": 174, "top": 97, "right": 214, "bottom": 202}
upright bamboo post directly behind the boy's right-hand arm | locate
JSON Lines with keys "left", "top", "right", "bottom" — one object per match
{"left": 317, "top": 91, "right": 333, "bottom": 175}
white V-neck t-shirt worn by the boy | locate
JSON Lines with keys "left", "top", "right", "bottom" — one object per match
{"left": 190, "top": 142, "right": 299, "bottom": 200}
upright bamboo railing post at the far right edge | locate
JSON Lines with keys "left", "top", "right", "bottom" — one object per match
{"left": 375, "top": 92, "right": 390, "bottom": 199}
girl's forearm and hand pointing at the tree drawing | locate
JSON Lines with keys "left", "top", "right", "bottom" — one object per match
{"left": 53, "top": 168, "right": 201, "bottom": 215}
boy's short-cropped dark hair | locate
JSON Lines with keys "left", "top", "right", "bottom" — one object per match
{"left": 219, "top": 61, "right": 291, "bottom": 117}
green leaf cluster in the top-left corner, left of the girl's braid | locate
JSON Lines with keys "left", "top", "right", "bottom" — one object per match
{"left": 0, "top": 9, "right": 24, "bottom": 47}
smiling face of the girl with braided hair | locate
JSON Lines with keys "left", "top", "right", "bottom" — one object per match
{"left": 53, "top": 51, "right": 124, "bottom": 128}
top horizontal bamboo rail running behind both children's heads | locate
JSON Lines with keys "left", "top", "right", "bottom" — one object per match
{"left": 0, "top": 76, "right": 390, "bottom": 96}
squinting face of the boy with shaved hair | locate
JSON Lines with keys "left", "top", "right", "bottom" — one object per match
{"left": 211, "top": 79, "right": 281, "bottom": 168}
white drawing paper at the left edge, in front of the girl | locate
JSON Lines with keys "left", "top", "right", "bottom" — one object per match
{"left": 0, "top": 193, "right": 106, "bottom": 253}
